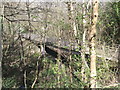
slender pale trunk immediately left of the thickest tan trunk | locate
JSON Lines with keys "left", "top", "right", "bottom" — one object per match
{"left": 81, "top": 0, "right": 90, "bottom": 86}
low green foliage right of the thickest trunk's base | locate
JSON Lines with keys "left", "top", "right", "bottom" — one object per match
{"left": 97, "top": 58, "right": 115, "bottom": 87}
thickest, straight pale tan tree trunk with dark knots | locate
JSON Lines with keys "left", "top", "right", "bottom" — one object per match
{"left": 89, "top": 0, "right": 98, "bottom": 88}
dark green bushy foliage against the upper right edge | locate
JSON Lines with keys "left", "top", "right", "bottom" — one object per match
{"left": 97, "top": 2, "right": 120, "bottom": 45}
